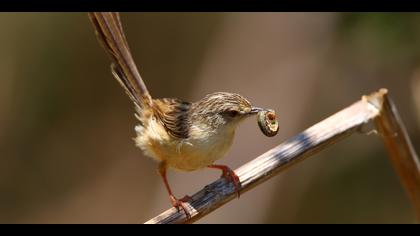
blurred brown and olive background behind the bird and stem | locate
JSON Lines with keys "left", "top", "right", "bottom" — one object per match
{"left": 0, "top": 13, "right": 420, "bottom": 223}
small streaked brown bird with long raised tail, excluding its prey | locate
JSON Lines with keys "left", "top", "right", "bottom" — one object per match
{"left": 89, "top": 12, "right": 272, "bottom": 217}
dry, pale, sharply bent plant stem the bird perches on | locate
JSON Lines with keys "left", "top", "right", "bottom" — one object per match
{"left": 146, "top": 89, "right": 420, "bottom": 224}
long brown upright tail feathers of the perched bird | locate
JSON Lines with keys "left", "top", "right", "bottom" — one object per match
{"left": 89, "top": 12, "right": 153, "bottom": 109}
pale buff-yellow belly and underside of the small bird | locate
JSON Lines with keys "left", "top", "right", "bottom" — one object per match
{"left": 136, "top": 121, "right": 234, "bottom": 171}
